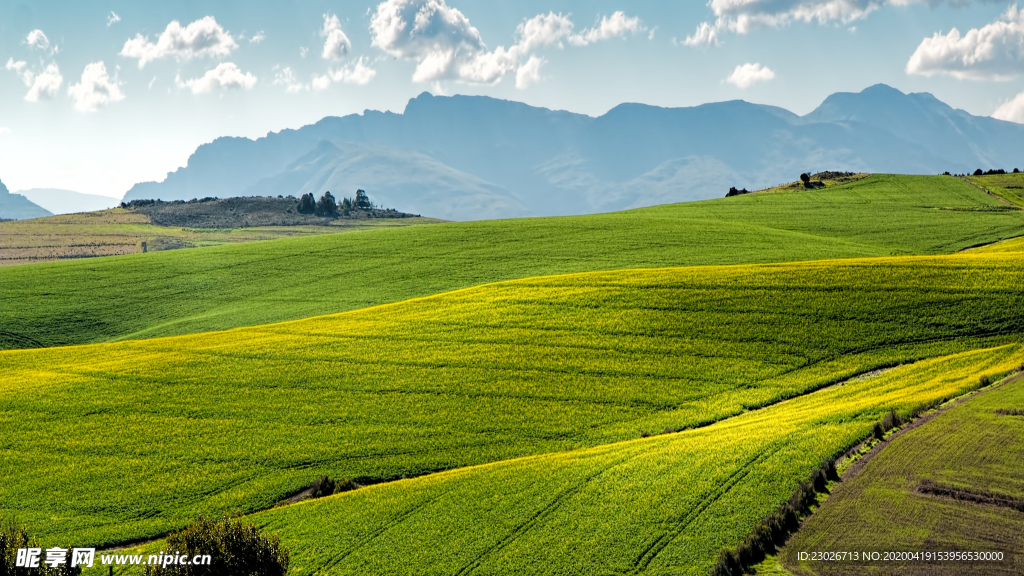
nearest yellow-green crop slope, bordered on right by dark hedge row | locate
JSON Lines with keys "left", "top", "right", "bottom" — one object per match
{"left": 114, "top": 345, "right": 1024, "bottom": 576}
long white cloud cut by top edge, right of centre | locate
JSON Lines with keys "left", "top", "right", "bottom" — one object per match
{"left": 683, "top": 0, "right": 994, "bottom": 46}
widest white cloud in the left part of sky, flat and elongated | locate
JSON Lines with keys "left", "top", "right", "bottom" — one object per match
{"left": 121, "top": 16, "right": 239, "bottom": 69}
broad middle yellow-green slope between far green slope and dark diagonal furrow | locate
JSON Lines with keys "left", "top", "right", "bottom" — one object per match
{"left": 0, "top": 248, "right": 1024, "bottom": 543}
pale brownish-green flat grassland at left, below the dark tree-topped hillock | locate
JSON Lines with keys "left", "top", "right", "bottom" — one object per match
{"left": 0, "top": 208, "right": 437, "bottom": 266}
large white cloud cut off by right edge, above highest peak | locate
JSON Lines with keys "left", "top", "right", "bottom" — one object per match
{"left": 906, "top": 5, "right": 1024, "bottom": 80}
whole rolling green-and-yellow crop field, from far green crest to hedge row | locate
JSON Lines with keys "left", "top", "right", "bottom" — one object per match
{"left": 0, "top": 175, "right": 1024, "bottom": 576}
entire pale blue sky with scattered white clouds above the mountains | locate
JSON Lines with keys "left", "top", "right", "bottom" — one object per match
{"left": 0, "top": 0, "right": 1024, "bottom": 198}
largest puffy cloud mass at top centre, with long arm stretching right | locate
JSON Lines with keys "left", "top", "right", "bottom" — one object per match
{"left": 370, "top": 0, "right": 646, "bottom": 84}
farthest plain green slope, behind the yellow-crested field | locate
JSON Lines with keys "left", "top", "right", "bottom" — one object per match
{"left": 0, "top": 175, "right": 1024, "bottom": 348}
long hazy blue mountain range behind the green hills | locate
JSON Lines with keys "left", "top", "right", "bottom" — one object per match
{"left": 125, "top": 84, "right": 1024, "bottom": 220}
